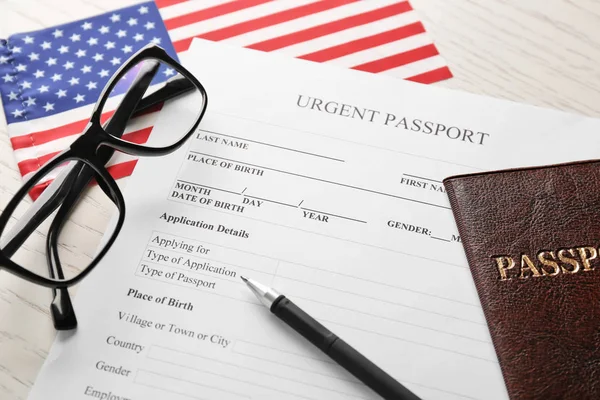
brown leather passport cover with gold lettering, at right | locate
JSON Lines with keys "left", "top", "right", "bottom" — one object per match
{"left": 444, "top": 161, "right": 600, "bottom": 400}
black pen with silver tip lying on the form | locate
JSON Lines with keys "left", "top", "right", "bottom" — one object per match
{"left": 241, "top": 276, "right": 420, "bottom": 400}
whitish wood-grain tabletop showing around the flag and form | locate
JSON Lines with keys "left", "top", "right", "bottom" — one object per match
{"left": 0, "top": 0, "right": 600, "bottom": 400}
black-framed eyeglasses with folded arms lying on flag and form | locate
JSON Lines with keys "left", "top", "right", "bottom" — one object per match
{"left": 0, "top": 45, "right": 208, "bottom": 330}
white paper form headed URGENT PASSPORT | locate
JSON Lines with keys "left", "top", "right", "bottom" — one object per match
{"left": 30, "top": 40, "right": 600, "bottom": 400}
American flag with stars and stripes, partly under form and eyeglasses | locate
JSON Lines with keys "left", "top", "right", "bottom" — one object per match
{"left": 0, "top": 0, "right": 452, "bottom": 198}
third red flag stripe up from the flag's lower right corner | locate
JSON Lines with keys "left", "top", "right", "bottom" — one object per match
{"left": 298, "top": 22, "right": 425, "bottom": 62}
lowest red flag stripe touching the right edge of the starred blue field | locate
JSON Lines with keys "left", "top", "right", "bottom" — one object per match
{"left": 173, "top": 0, "right": 358, "bottom": 52}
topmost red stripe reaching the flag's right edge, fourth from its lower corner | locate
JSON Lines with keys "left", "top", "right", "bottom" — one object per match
{"left": 247, "top": 1, "right": 412, "bottom": 51}
